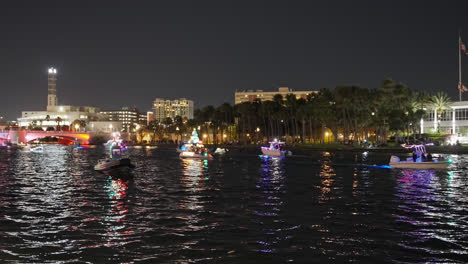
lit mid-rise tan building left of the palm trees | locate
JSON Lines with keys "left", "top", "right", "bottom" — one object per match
{"left": 153, "top": 98, "right": 193, "bottom": 122}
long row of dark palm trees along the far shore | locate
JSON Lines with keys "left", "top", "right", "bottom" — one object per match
{"left": 140, "top": 79, "right": 451, "bottom": 143}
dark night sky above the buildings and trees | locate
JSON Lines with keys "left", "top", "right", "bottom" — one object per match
{"left": 0, "top": 0, "right": 468, "bottom": 120}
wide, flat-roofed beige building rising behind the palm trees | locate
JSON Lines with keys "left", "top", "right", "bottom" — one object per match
{"left": 234, "top": 87, "right": 317, "bottom": 104}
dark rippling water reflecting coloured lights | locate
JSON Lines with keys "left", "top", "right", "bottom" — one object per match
{"left": 0, "top": 146, "right": 468, "bottom": 263}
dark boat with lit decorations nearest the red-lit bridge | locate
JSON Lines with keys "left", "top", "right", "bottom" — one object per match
{"left": 94, "top": 136, "right": 135, "bottom": 172}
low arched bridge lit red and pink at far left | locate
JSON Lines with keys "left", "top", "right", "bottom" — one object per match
{"left": 0, "top": 130, "right": 90, "bottom": 144}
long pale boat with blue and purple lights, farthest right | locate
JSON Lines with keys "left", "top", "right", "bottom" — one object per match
{"left": 388, "top": 145, "right": 452, "bottom": 170}
